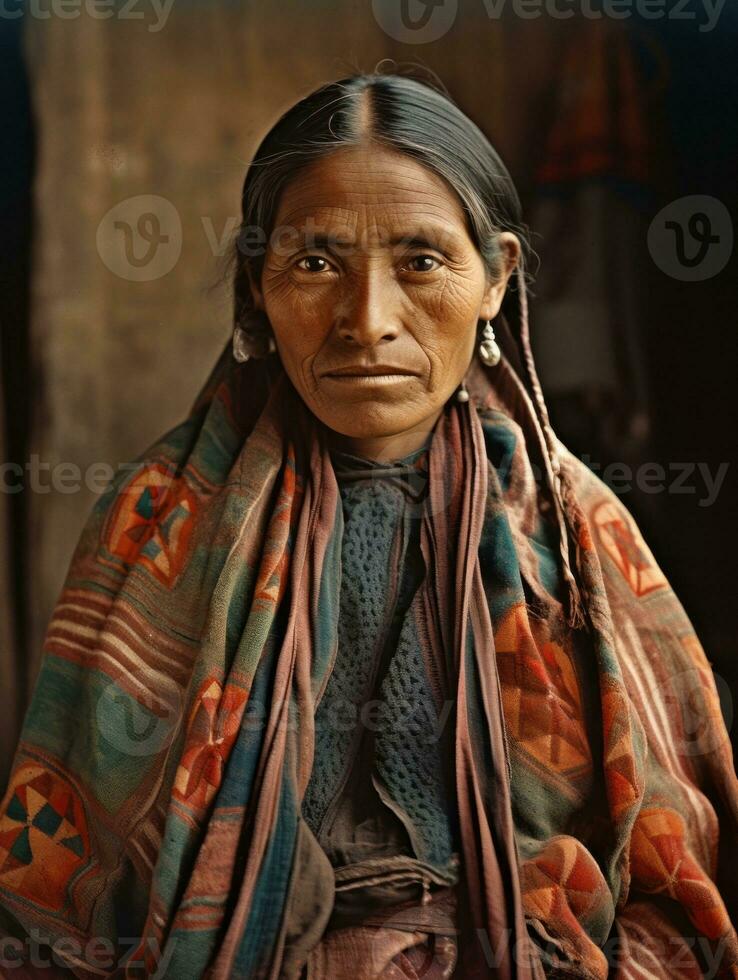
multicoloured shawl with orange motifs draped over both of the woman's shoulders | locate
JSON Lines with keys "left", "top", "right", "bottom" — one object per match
{"left": 0, "top": 338, "right": 738, "bottom": 980}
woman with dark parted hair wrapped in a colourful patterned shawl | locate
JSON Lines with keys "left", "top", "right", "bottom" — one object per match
{"left": 0, "top": 75, "right": 738, "bottom": 980}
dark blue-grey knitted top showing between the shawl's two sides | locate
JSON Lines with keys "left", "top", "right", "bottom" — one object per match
{"left": 302, "top": 447, "right": 454, "bottom": 869}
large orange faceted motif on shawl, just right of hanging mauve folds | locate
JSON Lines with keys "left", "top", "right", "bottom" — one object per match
{"left": 495, "top": 604, "right": 592, "bottom": 773}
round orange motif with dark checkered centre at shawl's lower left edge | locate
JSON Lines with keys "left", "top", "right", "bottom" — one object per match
{"left": 0, "top": 763, "right": 90, "bottom": 911}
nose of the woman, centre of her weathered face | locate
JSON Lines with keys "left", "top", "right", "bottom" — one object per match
{"left": 337, "top": 269, "right": 401, "bottom": 347}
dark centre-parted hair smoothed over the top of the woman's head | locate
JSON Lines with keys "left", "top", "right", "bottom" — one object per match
{"left": 230, "top": 74, "right": 530, "bottom": 336}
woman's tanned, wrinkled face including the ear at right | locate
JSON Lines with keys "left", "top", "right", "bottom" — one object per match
{"left": 254, "top": 144, "right": 519, "bottom": 459}
